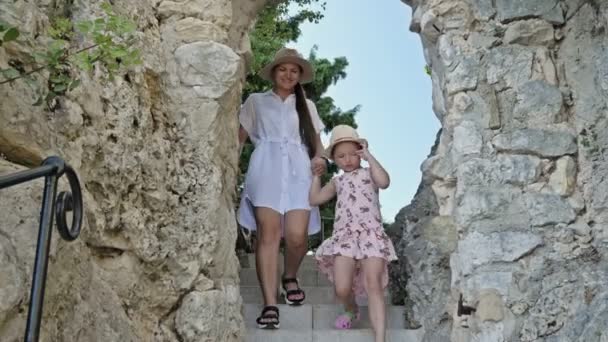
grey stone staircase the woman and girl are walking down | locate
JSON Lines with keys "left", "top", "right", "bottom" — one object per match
{"left": 240, "top": 254, "right": 422, "bottom": 342}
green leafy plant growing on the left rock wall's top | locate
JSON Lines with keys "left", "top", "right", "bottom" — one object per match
{"left": 0, "top": 3, "right": 141, "bottom": 108}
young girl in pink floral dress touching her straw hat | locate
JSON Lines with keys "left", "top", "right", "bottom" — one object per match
{"left": 309, "top": 125, "right": 397, "bottom": 342}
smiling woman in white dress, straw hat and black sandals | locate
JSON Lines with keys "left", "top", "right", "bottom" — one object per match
{"left": 238, "top": 49, "right": 326, "bottom": 329}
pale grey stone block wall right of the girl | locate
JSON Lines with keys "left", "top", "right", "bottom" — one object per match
{"left": 392, "top": 0, "right": 608, "bottom": 341}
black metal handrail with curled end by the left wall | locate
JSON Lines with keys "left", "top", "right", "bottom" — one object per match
{"left": 0, "top": 157, "right": 83, "bottom": 342}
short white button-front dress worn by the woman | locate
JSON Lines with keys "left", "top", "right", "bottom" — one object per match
{"left": 237, "top": 91, "right": 325, "bottom": 234}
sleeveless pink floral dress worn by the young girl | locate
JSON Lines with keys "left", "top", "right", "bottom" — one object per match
{"left": 315, "top": 168, "right": 397, "bottom": 297}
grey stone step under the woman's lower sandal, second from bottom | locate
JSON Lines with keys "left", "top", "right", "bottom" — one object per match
{"left": 243, "top": 304, "right": 405, "bottom": 330}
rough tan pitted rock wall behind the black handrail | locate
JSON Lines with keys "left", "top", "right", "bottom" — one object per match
{"left": 0, "top": 0, "right": 265, "bottom": 342}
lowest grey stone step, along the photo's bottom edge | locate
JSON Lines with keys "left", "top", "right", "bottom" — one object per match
{"left": 245, "top": 329, "right": 422, "bottom": 342}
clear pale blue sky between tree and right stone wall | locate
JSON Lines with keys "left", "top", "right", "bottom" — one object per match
{"left": 289, "top": 0, "right": 440, "bottom": 222}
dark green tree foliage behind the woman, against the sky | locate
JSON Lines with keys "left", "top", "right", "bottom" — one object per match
{"left": 237, "top": 0, "right": 359, "bottom": 248}
